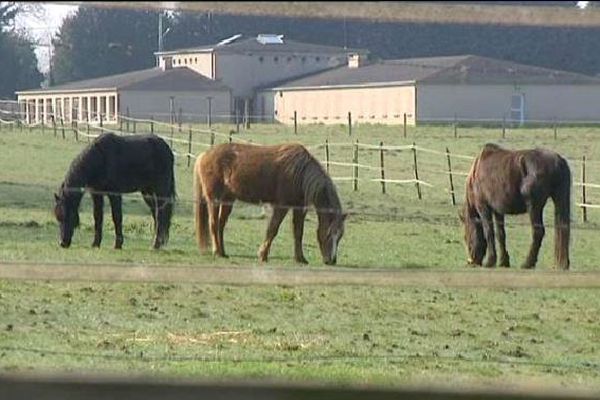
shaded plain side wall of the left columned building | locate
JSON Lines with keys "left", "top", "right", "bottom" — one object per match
{"left": 120, "top": 90, "right": 231, "bottom": 122}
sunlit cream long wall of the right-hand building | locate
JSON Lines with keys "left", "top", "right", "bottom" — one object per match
{"left": 257, "top": 85, "right": 415, "bottom": 125}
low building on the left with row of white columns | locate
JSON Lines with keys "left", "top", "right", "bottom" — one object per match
{"left": 17, "top": 68, "right": 231, "bottom": 124}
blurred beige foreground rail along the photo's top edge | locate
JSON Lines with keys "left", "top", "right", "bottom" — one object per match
{"left": 62, "top": 1, "right": 600, "bottom": 27}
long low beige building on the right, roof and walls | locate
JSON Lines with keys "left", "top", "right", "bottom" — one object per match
{"left": 257, "top": 55, "right": 600, "bottom": 124}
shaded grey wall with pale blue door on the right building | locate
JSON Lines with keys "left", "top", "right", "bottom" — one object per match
{"left": 417, "top": 84, "right": 600, "bottom": 122}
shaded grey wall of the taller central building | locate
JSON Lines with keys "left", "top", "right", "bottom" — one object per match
{"left": 215, "top": 52, "right": 347, "bottom": 98}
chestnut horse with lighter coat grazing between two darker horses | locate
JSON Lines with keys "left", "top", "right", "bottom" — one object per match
{"left": 194, "top": 143, "right": 346, "bottom": 265}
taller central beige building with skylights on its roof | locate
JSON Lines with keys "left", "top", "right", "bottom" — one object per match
{"left": 155, "top": 34, "right": 368, "bottom": 113}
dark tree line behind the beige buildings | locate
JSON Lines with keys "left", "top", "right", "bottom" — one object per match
{"left": 0, "top": 2, "right": 600, "bottom": 97}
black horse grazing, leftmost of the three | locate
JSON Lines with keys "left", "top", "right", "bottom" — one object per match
{"left": 54, "top": 133, "right": 175, "bottom": 249}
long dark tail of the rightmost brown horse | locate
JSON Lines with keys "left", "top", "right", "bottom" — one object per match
{"left": 552, "top": 157, "right": 571, "bottom": 270}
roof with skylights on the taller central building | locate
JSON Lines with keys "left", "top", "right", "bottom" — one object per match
{"left": 155, "top": 35, "right": 368, "bottom": 55}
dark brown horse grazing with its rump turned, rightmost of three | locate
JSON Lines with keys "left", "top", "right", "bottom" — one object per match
{"left": 461, "top": 144, "right": 571, "bottom": 269}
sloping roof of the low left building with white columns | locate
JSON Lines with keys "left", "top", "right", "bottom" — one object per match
{"left": 17, "top": 67, "right": 229, "bottom": 94}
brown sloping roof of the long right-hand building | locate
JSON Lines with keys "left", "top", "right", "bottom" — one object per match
{"left": 270, "top": 55, "right": 600, "bottom": 89}
